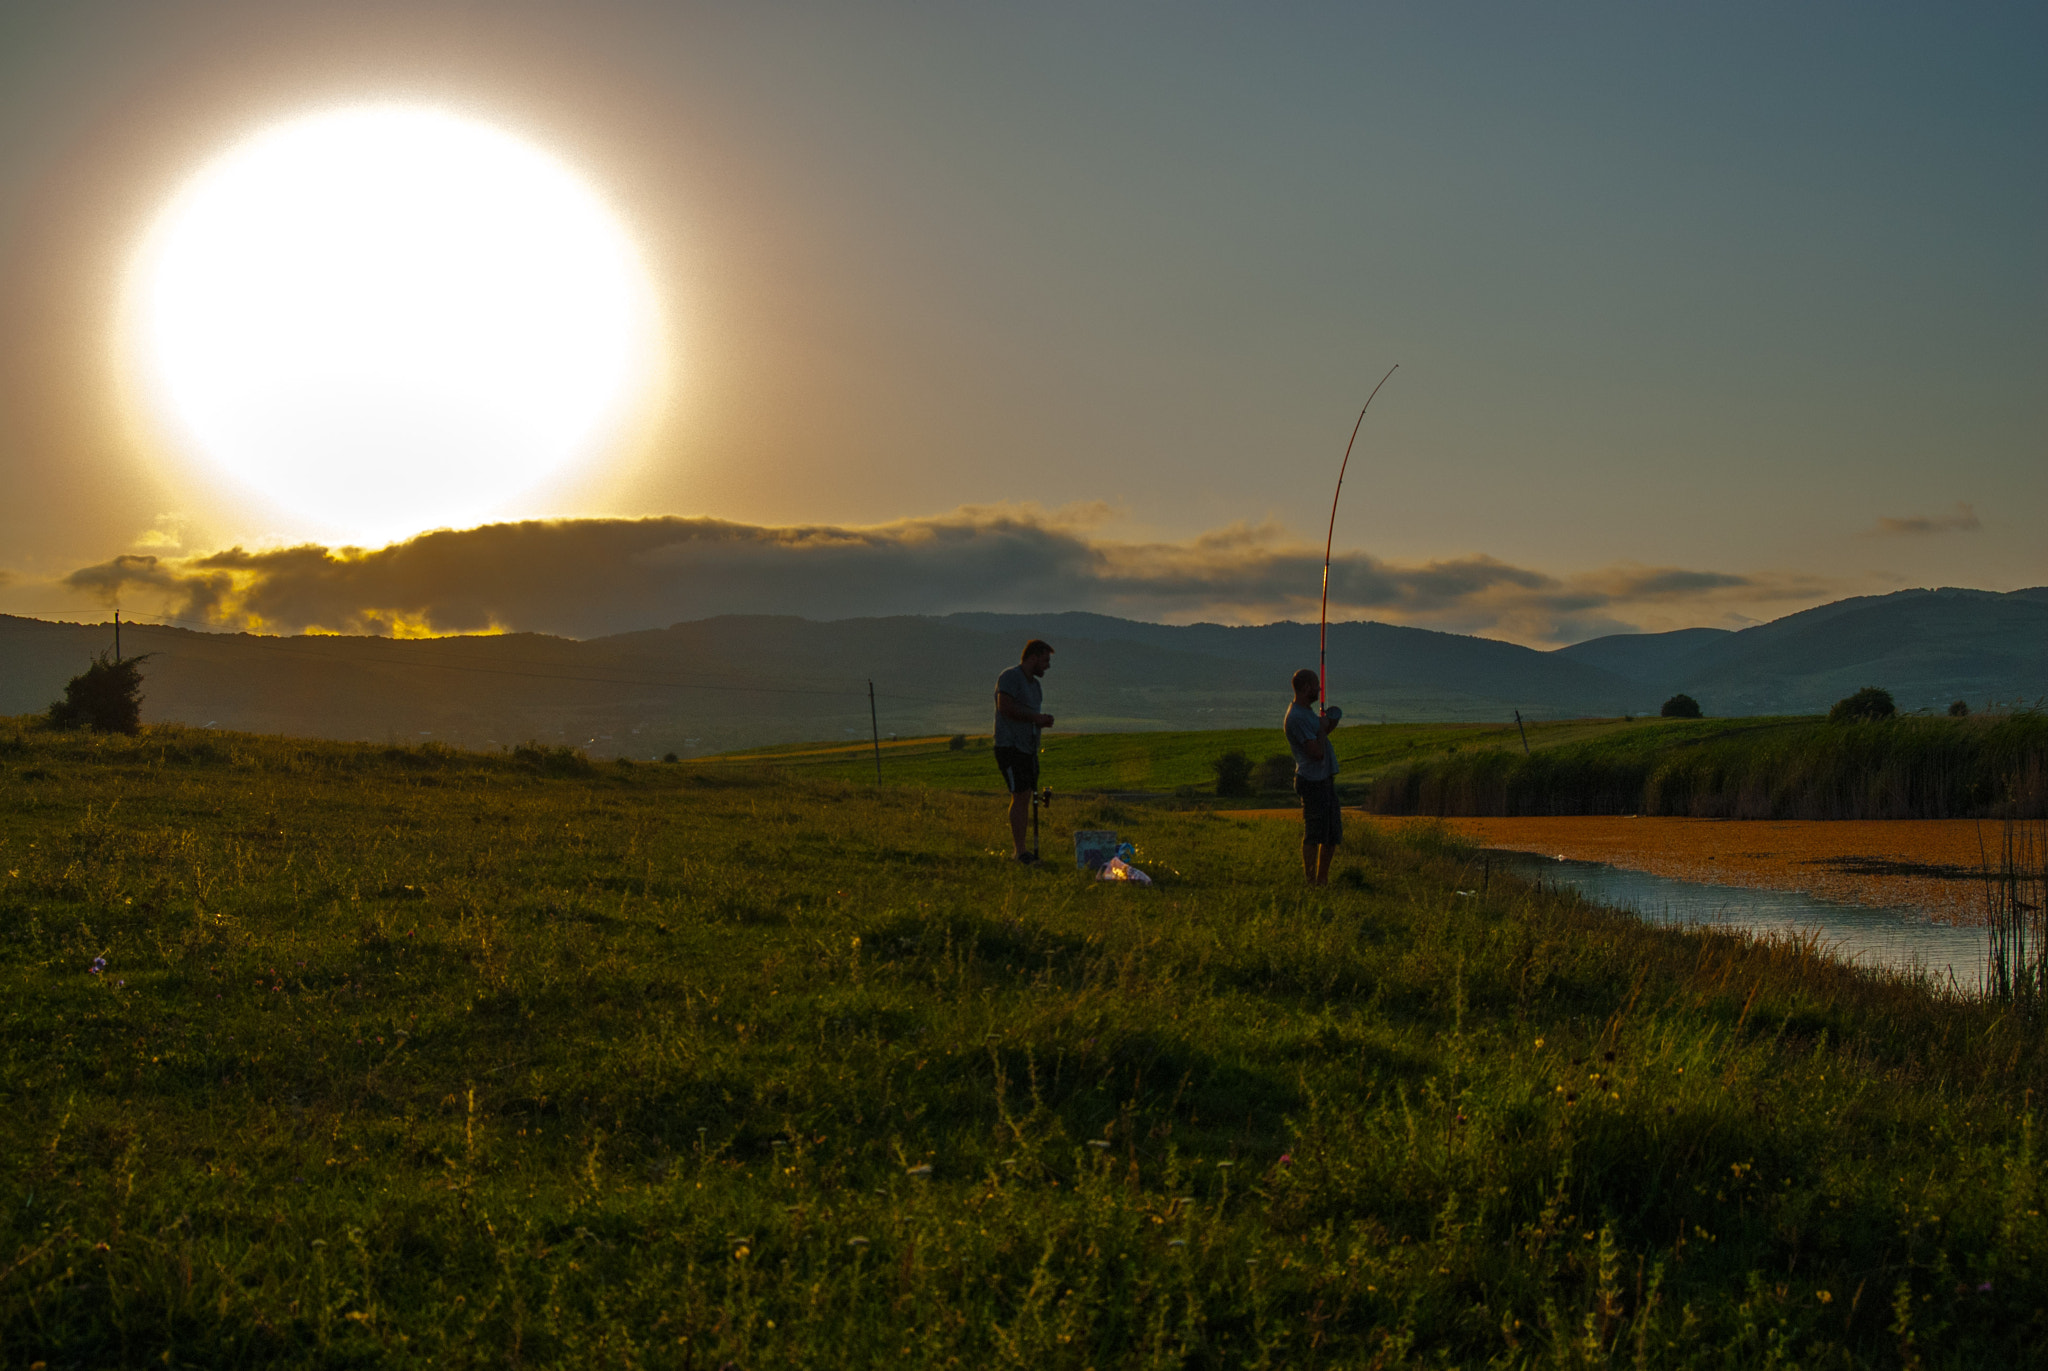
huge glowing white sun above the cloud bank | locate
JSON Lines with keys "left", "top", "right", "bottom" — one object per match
{"left": 125, "top": 105, "right": 659, "bottom": 539}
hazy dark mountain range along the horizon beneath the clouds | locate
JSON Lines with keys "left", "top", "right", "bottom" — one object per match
{"left": 0, "top": 588, "right": 2048, "bottom": 756}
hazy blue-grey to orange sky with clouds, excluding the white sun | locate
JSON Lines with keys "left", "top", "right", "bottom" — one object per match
{"left": 0, "top": 0, "right": 2048, "bottom": 646}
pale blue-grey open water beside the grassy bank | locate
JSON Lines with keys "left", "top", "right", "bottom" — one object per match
{"left": 1487, "top": 850, "right": 1987, "bottom": 992}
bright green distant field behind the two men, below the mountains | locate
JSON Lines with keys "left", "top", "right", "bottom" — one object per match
{"left": 692, "top": 701, "right": 1714, "bottom": 803}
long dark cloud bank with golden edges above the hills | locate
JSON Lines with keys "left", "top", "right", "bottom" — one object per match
{"left": 66, "top": 506, "right": 1831, "bottom": 643}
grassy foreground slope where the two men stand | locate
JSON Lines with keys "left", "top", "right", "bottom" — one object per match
{"left": 0, "top": 721, "right": 2048, "bottom": 1371}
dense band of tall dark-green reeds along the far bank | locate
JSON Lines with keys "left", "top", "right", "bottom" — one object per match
{"left": 1360, "top": 711, "right": 2048, "bottom": 820}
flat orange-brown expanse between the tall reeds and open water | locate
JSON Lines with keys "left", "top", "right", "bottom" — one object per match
{"left": 1233, "top": 809, "right": 1999, "bottom": 924}
